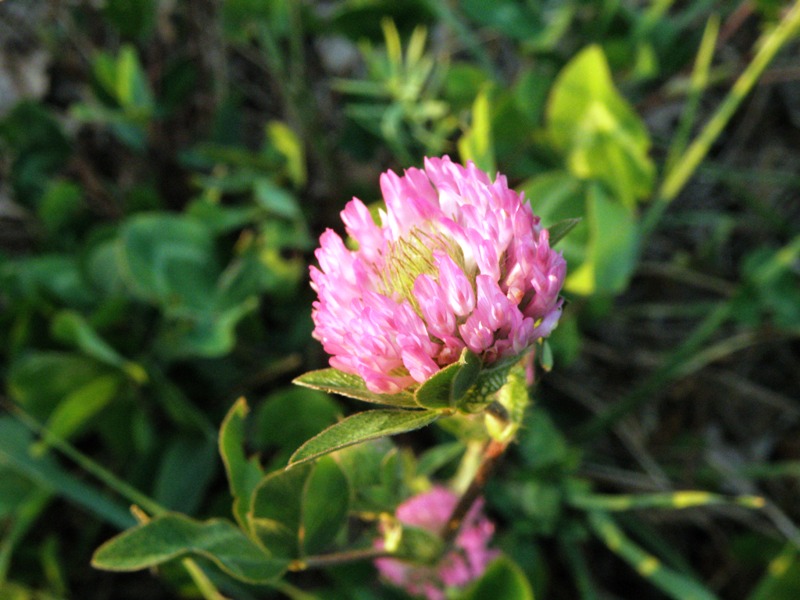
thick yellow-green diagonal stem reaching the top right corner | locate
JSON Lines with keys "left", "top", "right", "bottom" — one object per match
{"left": 642, "top": 0, "right": 800, "bottom": 235}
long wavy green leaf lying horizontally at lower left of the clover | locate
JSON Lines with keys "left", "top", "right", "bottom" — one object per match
{"left": 92, "top": 514, "right": 288, "bottom": 583}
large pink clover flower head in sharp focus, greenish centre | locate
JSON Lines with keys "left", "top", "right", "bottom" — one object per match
{"left": 310, "top": 156, "right": 566, "bottom": 393}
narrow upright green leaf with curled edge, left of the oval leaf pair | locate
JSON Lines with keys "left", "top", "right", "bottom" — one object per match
{"left": 219, "top": 398, "right": 264, "bottom": 529}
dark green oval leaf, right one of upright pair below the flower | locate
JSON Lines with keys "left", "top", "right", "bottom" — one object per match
{"left": 299, "top": 456, "right": 350, "bottom": 555}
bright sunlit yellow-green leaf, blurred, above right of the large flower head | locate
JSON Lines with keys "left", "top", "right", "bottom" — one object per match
{"left": 547, "top": 46, "right": 655, "bottom": 207}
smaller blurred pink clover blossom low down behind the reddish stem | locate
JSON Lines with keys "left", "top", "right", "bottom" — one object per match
{"left": 375, "top": 487, "right": 500, "bottom": 600}
